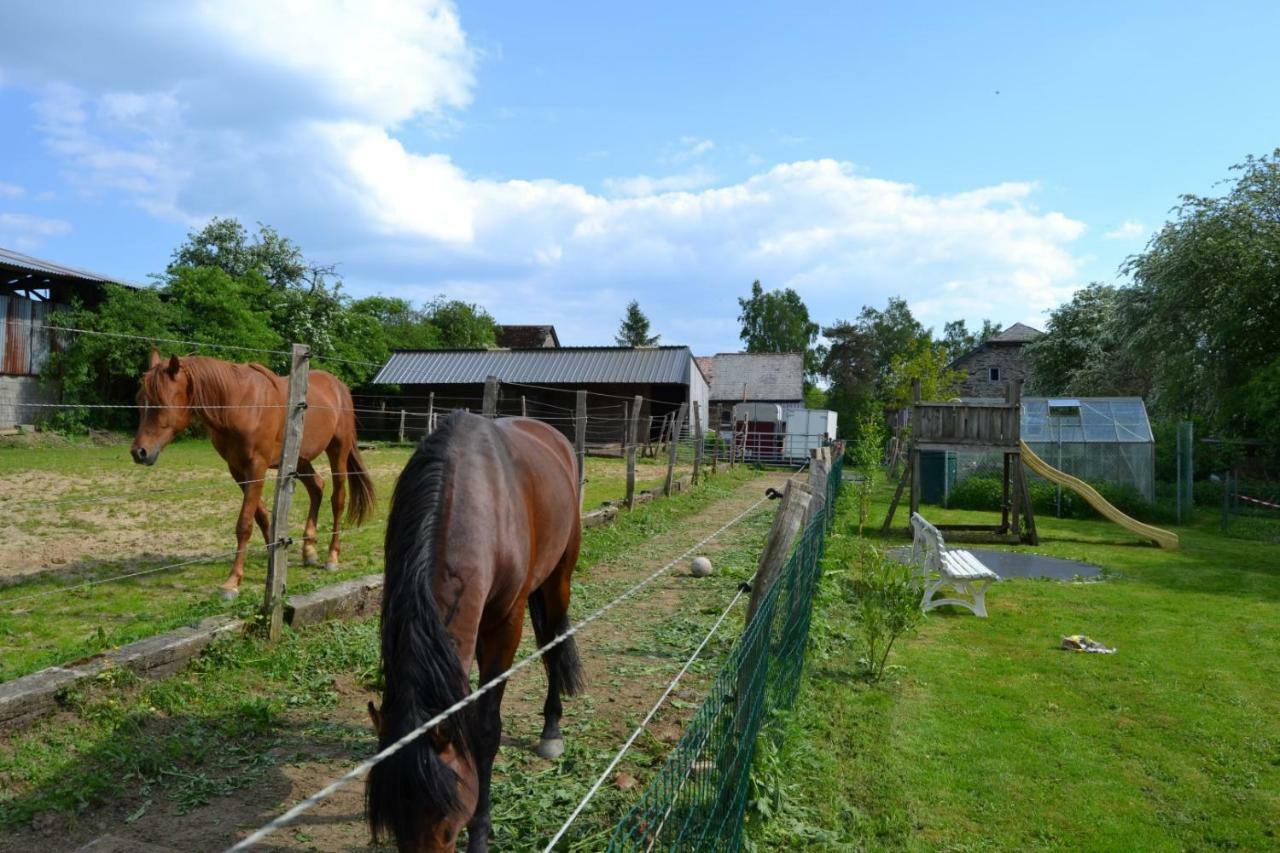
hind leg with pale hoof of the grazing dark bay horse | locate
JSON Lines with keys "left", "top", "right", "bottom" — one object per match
{"left": 529, "top": 544, "right": 582, "bottom": 761}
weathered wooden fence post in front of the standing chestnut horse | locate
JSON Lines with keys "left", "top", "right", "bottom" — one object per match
{"left": 262, "top": 343, "right": 311, "bottom": 640}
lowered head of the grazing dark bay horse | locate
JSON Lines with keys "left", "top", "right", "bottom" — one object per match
{"left": 369, "top": 702, "right": 480, "bottom": 853}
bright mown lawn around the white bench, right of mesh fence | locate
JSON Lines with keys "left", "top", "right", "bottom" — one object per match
{"left": 754, "top": 481, "right": 1280, "bottom": 850}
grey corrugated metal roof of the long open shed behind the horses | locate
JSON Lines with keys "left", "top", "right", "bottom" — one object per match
{"left": 374, "top": 347, "right": 694, "bottom": 386}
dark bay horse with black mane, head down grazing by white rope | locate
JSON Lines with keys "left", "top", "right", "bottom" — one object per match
{"left": 367, "top": 412, "right": 582, "bottom": 853}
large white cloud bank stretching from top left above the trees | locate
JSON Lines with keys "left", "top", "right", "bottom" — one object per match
{"left": 0, "top": 0, "right": 1084, "bottom": 350}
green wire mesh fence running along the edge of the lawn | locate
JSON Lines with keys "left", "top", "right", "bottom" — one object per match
{"left": 608, "top": 456, "right": 842, "bottom": 850}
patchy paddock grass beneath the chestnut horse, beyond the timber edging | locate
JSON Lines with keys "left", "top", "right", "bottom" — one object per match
{"left": 0, "top": 439, "right": 687, "bottom": 681}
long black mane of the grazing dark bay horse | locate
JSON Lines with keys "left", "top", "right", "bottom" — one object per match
{"left": 366, "top": 418, "right": 475, "bottom": 849}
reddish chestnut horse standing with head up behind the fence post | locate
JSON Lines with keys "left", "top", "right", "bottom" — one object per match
{"left": 129, "top": 350, "right": 374, "bottom": 598}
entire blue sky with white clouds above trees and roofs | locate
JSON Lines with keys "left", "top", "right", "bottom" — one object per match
{"left": 0, "top": 0, "right": 1280, "bottom": 352}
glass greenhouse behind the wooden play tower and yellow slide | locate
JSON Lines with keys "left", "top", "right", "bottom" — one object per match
{"left": 942, "top": 397, "right": 1156, "bottom": 501}
